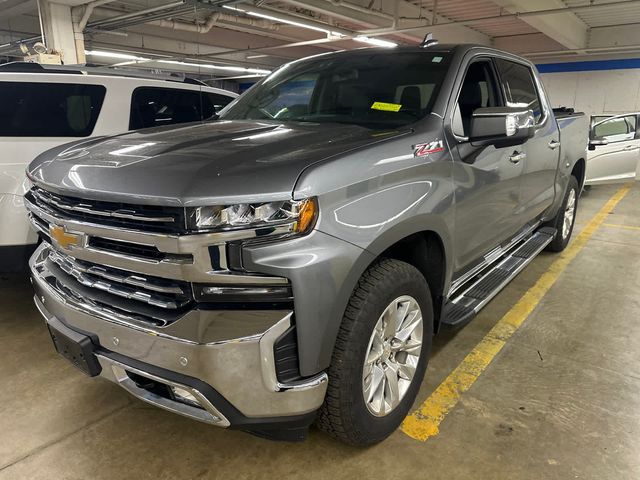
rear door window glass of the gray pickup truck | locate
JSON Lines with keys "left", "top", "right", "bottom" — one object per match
{"left": 496, "top": 58, "right": 543, "bottom": 123}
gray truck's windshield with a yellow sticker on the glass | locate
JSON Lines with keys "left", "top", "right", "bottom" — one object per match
{"left": 220, "top": 51, "right": 449, "bottom": 129}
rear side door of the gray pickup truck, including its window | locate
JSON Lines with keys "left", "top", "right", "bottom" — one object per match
{"left": 496, "top": 58, "right": 560, "bottom": 225}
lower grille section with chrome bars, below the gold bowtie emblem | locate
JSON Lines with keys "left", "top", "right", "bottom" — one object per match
{"left": 49, "top": 249, "right": 192, "bottom": 310}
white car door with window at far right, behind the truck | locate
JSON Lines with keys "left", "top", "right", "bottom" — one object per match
{"left": 586, "top": 113, "right": 640, "bottom": 185}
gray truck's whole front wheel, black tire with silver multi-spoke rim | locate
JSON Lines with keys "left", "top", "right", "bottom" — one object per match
{"left": 317, "top": 260, "right": 433, "bottom": 446}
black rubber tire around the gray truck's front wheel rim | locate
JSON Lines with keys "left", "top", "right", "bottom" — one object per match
{"left": 316, "top": 259, "right": 433, "bottom": 447}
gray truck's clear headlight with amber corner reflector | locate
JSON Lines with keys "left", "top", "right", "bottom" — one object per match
{"left": 188, "top": 199, "right": 318, "bottom": 233}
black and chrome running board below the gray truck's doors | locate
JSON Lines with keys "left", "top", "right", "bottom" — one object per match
{"left": 440, "top": 227, "right": 556, "bottom": 329}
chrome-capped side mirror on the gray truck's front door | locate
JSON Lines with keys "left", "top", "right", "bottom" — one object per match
{"left": 469, "top": 107, "right": 536, "bottom": 144}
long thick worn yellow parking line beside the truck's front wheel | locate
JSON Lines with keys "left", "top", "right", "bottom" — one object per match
{"left": 401, "top": 184, "right": 632, "bottom": 442}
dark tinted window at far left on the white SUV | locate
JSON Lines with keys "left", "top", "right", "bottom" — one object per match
{"left": 0, "top": 82, "right": 106, "bottom": 137}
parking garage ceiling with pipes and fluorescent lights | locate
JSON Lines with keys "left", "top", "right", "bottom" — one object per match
{"left": 0, "top": 0, "right": 640, "bottom": 78}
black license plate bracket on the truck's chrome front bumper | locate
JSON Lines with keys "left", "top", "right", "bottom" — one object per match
{"left": 47, "top": 317, "right": 102, "bottom": 377}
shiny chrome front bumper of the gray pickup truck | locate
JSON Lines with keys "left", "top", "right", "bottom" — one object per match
{"left": 29, "top": 244, "right": 327, "bottom": 429}
